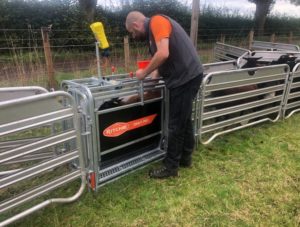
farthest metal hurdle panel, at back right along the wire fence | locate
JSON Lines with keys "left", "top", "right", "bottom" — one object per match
{"left": 251, "top": 40, "right": 300, "bottom": 52}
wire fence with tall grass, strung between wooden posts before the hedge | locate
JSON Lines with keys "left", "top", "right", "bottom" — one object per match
{"left": 0, "top": 29, "right": 300, "bottom": 86}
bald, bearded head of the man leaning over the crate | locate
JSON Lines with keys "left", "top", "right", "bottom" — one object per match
{"left": 125, "top": 11, "right": 146, "bottom": 40}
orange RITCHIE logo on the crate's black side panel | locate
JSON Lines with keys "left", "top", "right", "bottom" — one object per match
{"left": 103, "top": 114, "right": 157, "bottom": 137}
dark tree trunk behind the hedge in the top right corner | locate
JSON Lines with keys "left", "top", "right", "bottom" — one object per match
{"left": 248, "top": 0, "right": 300, "bottom": 35}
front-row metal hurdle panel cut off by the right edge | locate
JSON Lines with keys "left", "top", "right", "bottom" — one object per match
{"left": 283, "top": 63, "right": 300, "bottom": 119}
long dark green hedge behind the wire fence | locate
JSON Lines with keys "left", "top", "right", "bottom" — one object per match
{"left": 0, "top": 0, "right": 300, "bottom": 49}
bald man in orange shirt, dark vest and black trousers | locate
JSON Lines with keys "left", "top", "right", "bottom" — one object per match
{"left": 126, "top": 11, "right": 203, "bottom": 178}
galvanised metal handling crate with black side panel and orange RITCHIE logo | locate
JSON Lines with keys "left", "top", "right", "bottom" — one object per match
{"left": 62, "top": 74, "right": 167, "bottom": 191}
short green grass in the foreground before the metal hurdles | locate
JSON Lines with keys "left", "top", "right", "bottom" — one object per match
{"left": 6, "top": 115, "right": 300, "bottom": 227}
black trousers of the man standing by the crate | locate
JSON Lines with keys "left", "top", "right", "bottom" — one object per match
{"left": 163, "top": 74, "right": 202, "bottom": 169}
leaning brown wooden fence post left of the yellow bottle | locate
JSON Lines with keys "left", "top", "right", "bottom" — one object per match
{"left": 41, "top": 27, "right": 57, "bottom": 88}
